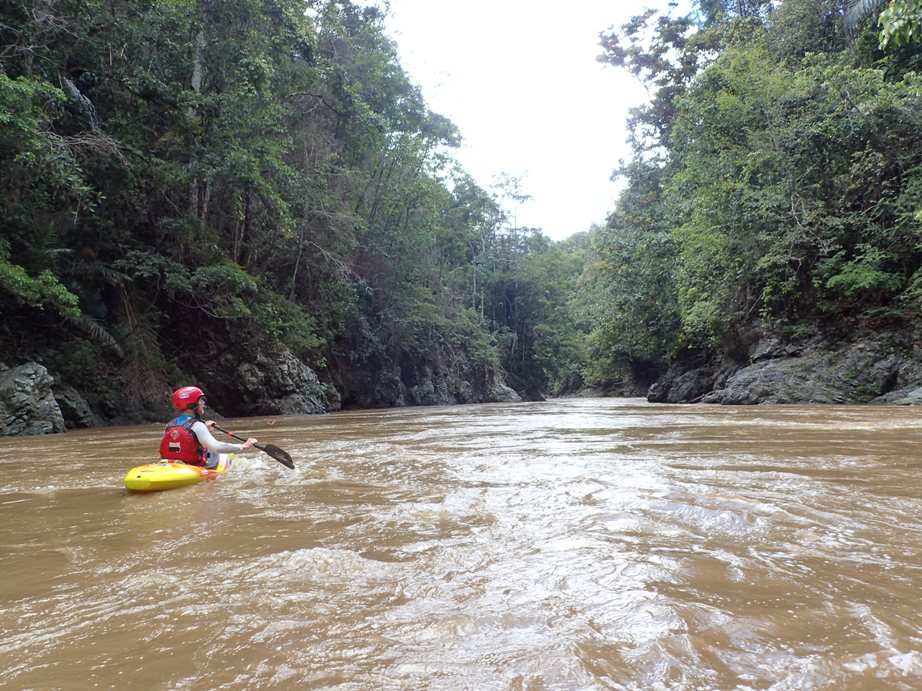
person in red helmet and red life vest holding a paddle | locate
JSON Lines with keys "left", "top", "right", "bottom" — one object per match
{"left": 160, "top": 386, "right": 258, "bottom": 468}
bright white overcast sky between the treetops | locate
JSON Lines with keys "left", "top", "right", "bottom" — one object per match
{"left": 387, "top": 0, "right": 684, "bottom": 240}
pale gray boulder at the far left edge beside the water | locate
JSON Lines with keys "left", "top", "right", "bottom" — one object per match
{"left": 0, "top": 362, "right": 65, "bottom": 436}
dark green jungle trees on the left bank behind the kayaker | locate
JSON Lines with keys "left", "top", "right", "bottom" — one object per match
{"left": 0, "top": 0, "right": 582, "bottom": 413}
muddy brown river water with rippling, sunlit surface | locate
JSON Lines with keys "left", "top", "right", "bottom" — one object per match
{"left": 0, "top": 399, "right": 922, "bottom": 690}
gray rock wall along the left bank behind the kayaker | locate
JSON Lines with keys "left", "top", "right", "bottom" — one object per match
{"left": 0, "top": 346, "right": 521, "bottom": 436}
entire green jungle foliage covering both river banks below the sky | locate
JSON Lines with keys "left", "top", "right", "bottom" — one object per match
{"left": 0, "top": 0, "right": 922, "bottom": 412}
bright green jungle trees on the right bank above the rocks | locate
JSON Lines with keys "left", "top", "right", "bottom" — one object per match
{"left": 582, "top": 0, "right": 922, "bottom": 386}
